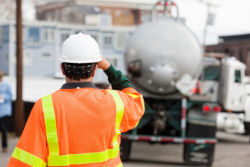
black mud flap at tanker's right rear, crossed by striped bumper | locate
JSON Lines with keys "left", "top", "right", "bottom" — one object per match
{"left": 183, "top": 123, "right": 216, "bottom": 166}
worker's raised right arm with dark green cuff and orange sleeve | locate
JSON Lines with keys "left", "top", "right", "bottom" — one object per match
{"left": 99, "top": 57, "right": 145, "bottom": 132}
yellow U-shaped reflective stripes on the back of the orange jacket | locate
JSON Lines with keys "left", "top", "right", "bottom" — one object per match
{"left": 42, "top": 90, "right": 124, "bottom": 167}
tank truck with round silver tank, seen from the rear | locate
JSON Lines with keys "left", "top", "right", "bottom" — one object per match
{"left": 120, "top": 1, "right": 221, "bottom": 165}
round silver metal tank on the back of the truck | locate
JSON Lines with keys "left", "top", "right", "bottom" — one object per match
{"left": 125, "top": 17, "right": 203, "bottom": 95}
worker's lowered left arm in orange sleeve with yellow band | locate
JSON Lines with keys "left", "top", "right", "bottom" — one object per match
{"left": 7, "top": 100, "right": 47, "bottom": 167}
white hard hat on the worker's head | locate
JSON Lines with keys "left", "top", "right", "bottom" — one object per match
{"left": 59, "top": 33, "right": 102, "bottom": 63}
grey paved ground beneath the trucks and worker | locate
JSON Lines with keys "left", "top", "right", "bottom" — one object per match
{"left": 0, "top": 132, "right": 250, "bottom": 167}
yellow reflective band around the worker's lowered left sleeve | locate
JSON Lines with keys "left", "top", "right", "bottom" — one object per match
{"left": 12, "top": 147, "right": 47, "bottom": 167}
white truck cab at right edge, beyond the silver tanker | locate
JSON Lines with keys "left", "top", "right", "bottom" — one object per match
{"left": 200, "top": 53, "right": 250, "bottom": 135}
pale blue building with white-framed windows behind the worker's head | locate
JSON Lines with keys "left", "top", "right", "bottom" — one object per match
{"left": 0, "top": 21, "right": 134, "bottom": 82}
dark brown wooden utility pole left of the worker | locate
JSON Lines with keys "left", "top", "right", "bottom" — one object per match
{"left": 15, "top": 0, "right": 24, "bottom": 136}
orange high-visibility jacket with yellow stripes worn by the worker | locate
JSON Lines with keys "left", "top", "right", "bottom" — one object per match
{"left": 8, "top": 88, "right": 145, "bottom": 167}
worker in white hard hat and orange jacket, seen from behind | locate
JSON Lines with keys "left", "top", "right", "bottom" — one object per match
{"left": 8, "top": 33, "right": 144, "bottom": 167}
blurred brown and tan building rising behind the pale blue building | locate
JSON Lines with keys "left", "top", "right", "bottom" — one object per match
{"left": 36, "top": 0, "right": 152, "bottom": 26}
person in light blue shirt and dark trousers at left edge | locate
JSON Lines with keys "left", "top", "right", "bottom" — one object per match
{"left": 0, "top": 70, "right": 12, "bottom": 153}
